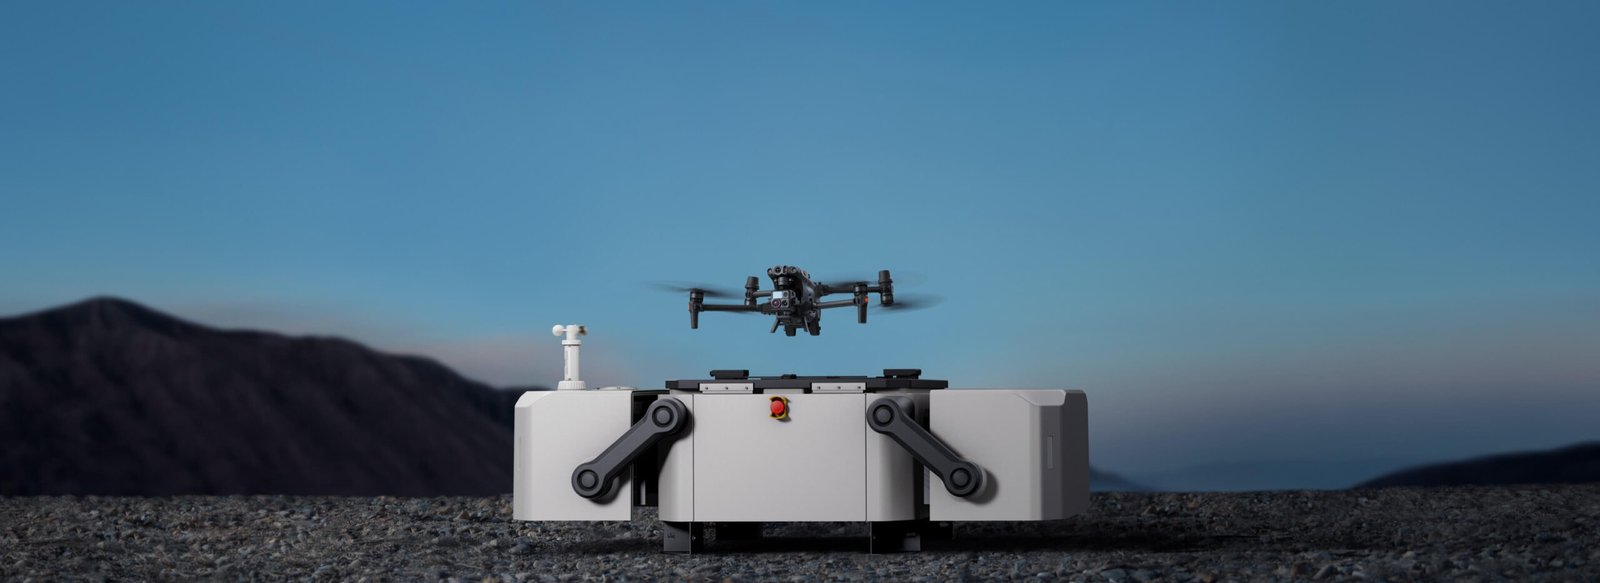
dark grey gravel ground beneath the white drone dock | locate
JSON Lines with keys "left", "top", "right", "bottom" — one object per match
{"left": 0, "top": 485, "right": 1600, "bottom": 581}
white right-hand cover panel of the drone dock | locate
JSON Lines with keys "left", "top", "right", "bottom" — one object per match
{"left": 928, "top": 389, "right": 1090, "bottom": 521}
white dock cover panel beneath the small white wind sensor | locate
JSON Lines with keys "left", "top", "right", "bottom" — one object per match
{"left": 512, "top": 389, "right": 634, "bottom": 521}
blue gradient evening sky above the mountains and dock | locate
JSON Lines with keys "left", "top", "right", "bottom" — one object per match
{"left": 0, "top": 2, "right": 1600, "bottom": 472}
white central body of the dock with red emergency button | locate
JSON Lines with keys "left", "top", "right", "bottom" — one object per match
{"left": 659, "top": 391, "right": 928, "bottom": 522}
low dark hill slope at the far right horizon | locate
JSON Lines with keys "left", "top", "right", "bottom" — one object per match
{"left": 1357, "top": 442, "right": 1600, "bottom": 489}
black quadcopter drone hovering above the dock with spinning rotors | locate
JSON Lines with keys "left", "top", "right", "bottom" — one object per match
{"left": 664, "top": 266, "right": 923, "bottom": 336}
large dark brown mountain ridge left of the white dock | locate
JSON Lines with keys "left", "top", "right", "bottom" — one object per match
{"left": 0, "top": 298, "right": 520, "bottom": 495}
